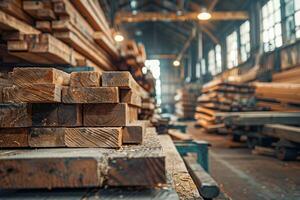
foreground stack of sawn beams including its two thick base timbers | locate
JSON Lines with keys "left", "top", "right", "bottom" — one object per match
{"left": 0, "top": 67, "right": 166, "bottom": 189}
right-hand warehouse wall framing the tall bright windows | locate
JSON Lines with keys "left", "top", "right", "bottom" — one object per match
{"left": 202, "top": 0, "right": 300, "bottom": 82}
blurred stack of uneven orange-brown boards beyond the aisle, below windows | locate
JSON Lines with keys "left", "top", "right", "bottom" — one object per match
{"left": 195, "top": 81, "right": 261, "bottom": 131}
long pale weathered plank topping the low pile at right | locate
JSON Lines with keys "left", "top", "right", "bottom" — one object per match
{"left": 216, "top": 111, "right": 300, "bottom": 125}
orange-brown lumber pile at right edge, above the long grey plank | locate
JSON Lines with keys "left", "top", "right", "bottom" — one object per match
{"left": 253, "top": 82, "right": 300, "bottom": 112}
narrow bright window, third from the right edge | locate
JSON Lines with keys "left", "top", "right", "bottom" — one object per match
{"left": 240, "top": 20, "right": 251, "bottom": 62}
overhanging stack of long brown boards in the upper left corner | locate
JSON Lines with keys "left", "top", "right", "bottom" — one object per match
{"left": 0, "top": 0, "right": 120, "bottom": 71}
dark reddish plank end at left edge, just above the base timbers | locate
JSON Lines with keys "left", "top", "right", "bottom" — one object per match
{"left": 0, "top": 128, "right": 29, "bottom": 148}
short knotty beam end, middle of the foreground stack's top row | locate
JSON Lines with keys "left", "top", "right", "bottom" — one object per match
{"left": 70, "top": 71, "right": 100, "bottom": 87}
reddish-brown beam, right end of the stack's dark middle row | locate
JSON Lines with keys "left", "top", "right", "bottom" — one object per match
{"left": 83, "top": 103, "right": 135, "bottom": 127}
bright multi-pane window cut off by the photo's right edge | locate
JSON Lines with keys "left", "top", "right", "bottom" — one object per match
{"left": 284, "top": 0, "right": 300, "bottom": 41}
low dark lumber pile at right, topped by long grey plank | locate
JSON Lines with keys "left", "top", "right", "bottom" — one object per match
{"left": 217, "top": 111, "right": 300, "bottom": 160}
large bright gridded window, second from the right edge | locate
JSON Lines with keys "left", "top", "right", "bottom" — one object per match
{"left": 262, "top": 0, "right": 282, "bottom": 52}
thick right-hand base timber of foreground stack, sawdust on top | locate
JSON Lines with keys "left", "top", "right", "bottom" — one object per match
{"left": 107, "top": 128, "right": 166, "bottom": 186}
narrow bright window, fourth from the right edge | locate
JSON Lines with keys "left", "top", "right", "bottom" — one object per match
{"left": 226, "top": 31, "right": 238, "bottom": 69}
